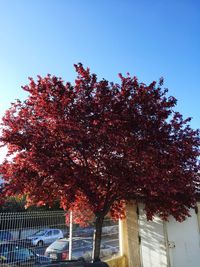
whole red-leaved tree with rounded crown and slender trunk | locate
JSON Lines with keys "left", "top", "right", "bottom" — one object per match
{"left": 0, "top": 64, "right": 200, "bottom": 261}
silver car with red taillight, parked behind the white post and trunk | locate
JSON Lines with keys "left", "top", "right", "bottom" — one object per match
{"left": 45, "top": 237, "right": 117, "bottom": 261}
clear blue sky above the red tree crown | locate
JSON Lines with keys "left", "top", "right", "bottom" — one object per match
{"left": 0, "top": 0, "right": 200, "bottom": 128}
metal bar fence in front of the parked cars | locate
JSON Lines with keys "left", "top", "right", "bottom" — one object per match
{"left": 0, "top": 211, "right": 119, "bottom": 263}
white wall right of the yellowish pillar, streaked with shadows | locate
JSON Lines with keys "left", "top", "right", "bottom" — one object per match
{"left": 139, "top": 205, "right": 200, "bottom": 267}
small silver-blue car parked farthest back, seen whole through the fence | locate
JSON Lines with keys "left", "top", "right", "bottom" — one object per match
{"left": 26, "top": 228, "right": 63, "bottom": 246}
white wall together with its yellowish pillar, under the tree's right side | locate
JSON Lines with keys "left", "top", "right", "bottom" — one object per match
{"left": 108, "top": 203, "right": 200, "bottom": 267}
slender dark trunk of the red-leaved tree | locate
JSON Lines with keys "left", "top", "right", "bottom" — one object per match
{"left": 92, "top": 215, "right": 104, "bottom": 262}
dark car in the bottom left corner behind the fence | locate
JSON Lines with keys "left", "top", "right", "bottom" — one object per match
{"left": 0, "top": 241, "right": 52, "bottom": 267}
